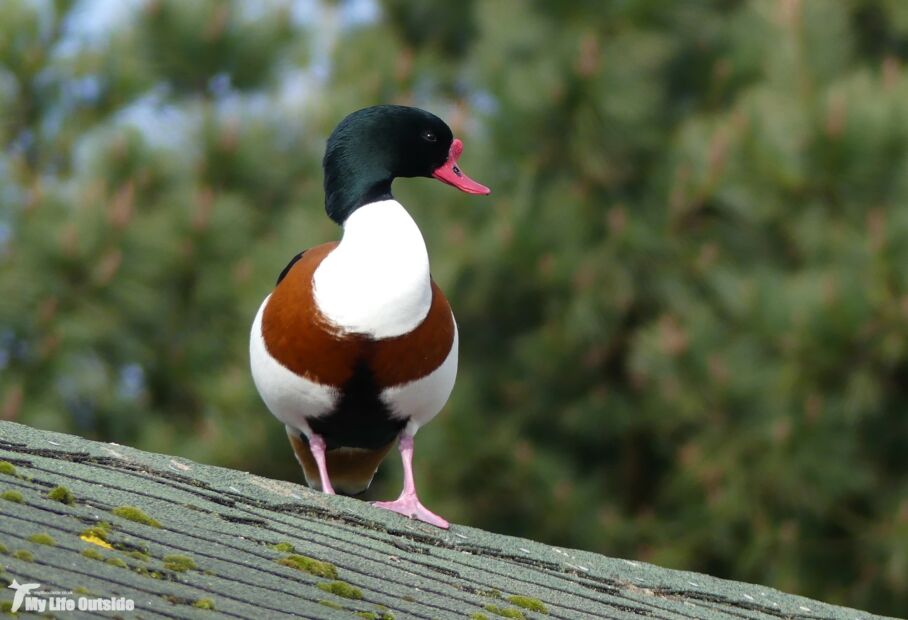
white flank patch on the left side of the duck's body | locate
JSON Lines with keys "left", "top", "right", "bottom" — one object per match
{"left": 249, "top": 295, "right": 339, "bottom": 435}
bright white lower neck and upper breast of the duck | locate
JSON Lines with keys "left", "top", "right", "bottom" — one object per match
{"left": 313, "top": 200, "right": 432, "bottom": 338}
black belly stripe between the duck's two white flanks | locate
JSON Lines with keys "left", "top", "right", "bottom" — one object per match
{"left": 309, "top": 363, "right": 407, "bottom": 450}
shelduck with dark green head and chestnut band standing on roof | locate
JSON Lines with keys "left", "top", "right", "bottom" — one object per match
{"left": 249, "top": 105, "right": 491, "bottom": 529}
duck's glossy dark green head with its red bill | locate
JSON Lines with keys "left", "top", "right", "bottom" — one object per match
{"left": 323, "top": 105, "right": 490, "bottom": 224}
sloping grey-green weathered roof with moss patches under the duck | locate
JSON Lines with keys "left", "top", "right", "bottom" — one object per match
{"left": 0, "top": 422, "right": 892, "bottom": 620}
